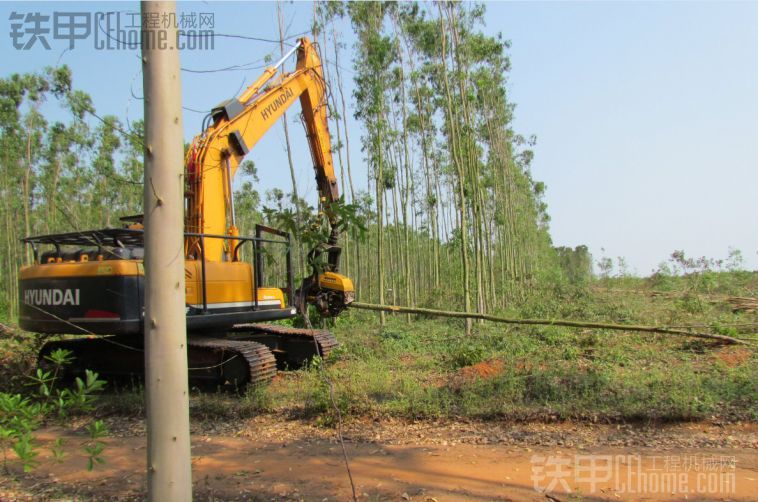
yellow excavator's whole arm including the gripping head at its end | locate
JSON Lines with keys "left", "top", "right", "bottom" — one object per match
{"left": 185, "top": 38, "right": 354, "bottom": 315}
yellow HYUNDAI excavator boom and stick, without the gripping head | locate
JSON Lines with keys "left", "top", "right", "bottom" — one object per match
{"left": 186, "top": 38, "right": 339, "bottom": 261}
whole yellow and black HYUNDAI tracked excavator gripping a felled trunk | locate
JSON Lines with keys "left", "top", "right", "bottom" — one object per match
{"left": 19, "top": 38, "right": 354, "bottom": 388}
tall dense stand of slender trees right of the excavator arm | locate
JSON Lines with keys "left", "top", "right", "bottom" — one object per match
{"left": 315, "top": 2, "right": 557, "bottom": 326}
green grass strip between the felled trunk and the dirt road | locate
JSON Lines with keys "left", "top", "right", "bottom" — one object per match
{"left": 269, "top": 319, "right": 758, "bottom": 421}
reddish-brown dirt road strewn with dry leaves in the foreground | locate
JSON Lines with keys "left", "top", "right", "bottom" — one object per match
{"left": 0, "top": 417, "right": 758, "bottom": 502}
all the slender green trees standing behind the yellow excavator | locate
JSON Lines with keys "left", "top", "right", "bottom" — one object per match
{"left": 0, "top": 2, "right": 580, "bottom": 326}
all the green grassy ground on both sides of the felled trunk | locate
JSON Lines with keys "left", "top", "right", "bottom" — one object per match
{"left": 3, "top": 274, "right": 758, "bottom": 425}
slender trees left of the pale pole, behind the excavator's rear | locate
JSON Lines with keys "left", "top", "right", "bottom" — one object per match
{"left": 0, "top": 66, "right": 143, "bottom": 318}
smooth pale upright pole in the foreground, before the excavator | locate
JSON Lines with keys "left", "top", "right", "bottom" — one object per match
{"left": 141, "top": 1, "right": 192, "bottom": 502}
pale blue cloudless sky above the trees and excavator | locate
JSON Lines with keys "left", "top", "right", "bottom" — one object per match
{"left": 0, "top": 2, "right": 758, "bottom": 274}
